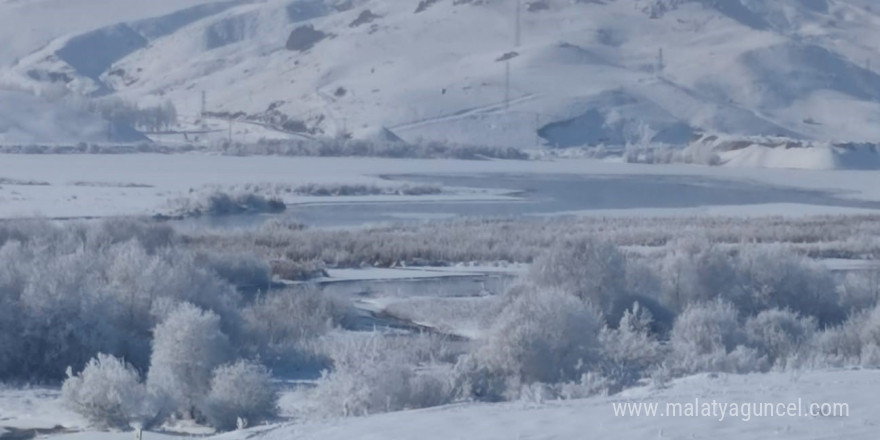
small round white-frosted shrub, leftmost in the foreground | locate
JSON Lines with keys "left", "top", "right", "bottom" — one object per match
{"left": 61, "top": 354, "right": 151, "bottom": 429}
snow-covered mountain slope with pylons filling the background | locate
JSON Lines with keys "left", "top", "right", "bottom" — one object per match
{"left": 0, "top": 0, "right": 880, "bottom": 147}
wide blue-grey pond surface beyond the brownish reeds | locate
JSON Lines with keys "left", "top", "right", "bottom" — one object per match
{"left": 189, "top": 174, "right": 880, "bottom": 227}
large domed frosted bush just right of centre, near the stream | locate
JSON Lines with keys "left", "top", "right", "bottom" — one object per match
{"left": 458, "top": 288, "right": 602, "bottom": 400}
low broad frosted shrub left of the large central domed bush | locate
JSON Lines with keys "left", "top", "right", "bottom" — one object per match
{"left": 310, "top": 334, "right": 453, "bottom": 418}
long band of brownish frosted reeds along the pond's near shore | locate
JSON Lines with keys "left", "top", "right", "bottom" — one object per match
{"left": 199, "top": 216, "right": 880, "bottom": 272}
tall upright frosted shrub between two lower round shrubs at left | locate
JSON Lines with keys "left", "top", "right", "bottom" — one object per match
{"left": 147, "top": 303, "right": 230, "bottom": 416}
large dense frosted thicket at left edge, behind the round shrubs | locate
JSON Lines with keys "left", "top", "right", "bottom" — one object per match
{"left": 0, "top": 219, "right": 248, "bottom": 381}
